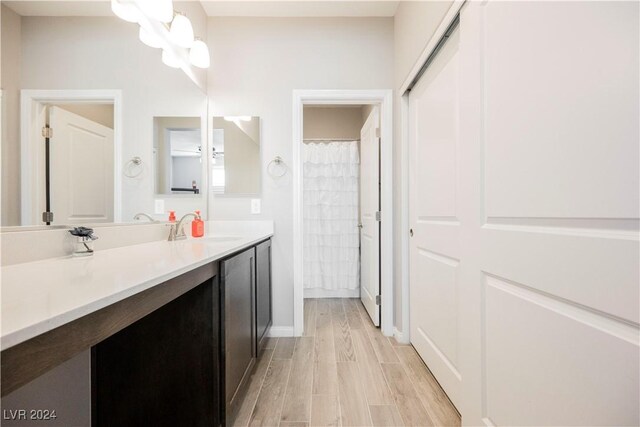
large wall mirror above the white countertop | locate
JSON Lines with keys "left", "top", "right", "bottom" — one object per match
{"left": 0, "top": 1, "right": 210, "bottom": 227}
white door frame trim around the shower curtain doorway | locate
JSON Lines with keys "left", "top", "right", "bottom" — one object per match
{"left": 291, "top": 89, "right": 394, "bottom": 336}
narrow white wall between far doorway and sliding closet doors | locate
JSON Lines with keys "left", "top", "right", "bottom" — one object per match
{"left": 393, "top": 1, "right": 453, "bottom": 331}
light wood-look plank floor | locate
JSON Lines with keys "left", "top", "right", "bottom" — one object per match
{"left": 233, "top": 299, "right": 460, "bottom": 427}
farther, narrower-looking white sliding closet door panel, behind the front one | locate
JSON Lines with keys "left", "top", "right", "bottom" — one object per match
{"left": 409, "top": 25, "right": 461, "bottom": 405}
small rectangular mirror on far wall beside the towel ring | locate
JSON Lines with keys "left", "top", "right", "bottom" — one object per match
{"left": 211, "top": 116, "right": 262, "bottom": 195}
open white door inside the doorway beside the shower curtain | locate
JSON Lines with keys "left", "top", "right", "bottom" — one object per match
{"left": 360, "top": 106, "right": 380, "bottom": 326}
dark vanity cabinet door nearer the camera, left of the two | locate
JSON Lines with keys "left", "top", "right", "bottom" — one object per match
{"left": 221, "top": 248, "right": 256, "bottom": 417}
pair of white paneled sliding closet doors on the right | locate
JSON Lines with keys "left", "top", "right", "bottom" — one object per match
{"left": 409, "top": 1, "right": 640, "bottom": 426}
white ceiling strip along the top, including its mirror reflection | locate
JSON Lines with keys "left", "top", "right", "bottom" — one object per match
{"left": 2, "top": 0, "right": 400, "bottom": 17}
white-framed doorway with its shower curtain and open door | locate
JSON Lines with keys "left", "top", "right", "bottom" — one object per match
{"left": 293, "top": 91, "right": 393, "bottom": 336}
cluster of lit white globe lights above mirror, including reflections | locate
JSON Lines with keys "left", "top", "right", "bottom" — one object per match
{"left": 111, "top": 0, "right": 211, "bottom": 70}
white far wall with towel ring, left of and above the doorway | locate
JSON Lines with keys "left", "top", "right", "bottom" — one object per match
{"left": 208, "top": 18, "right": 393, "bottom": 327}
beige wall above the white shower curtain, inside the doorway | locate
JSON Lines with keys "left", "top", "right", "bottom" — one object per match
{"left": 302, "top": 106, "right": 366, "bottom": 139}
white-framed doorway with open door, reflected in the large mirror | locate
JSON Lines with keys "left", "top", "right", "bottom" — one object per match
{"left": 21, "top": 90, "right": 121, "bottom": 225}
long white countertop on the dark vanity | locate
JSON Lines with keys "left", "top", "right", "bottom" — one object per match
{"left": 0, "top": 230, "right": 273, "bottom": 350}
